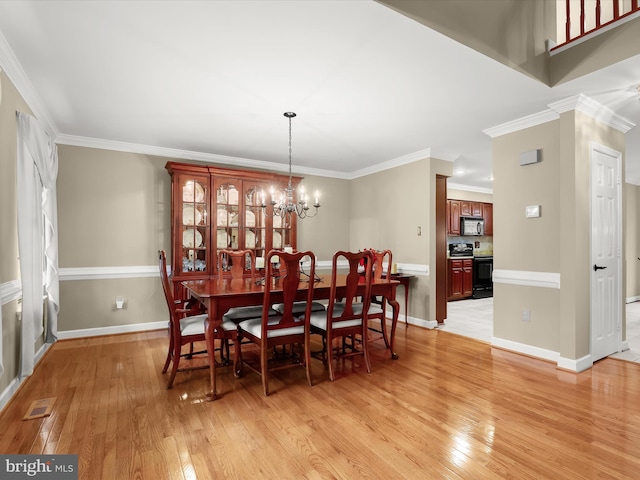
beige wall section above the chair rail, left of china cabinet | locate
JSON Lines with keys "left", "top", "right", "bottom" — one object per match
{"left": 58, "top": 145, "right": 171, "bottom": 268}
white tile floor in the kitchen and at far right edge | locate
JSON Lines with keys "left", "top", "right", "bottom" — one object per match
{"left": 438, "top": 298, "right": 640, "bottom": 363}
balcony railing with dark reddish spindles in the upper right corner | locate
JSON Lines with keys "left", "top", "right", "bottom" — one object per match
{"left": 551, "top": 0, "right": 640, "bottom": 51}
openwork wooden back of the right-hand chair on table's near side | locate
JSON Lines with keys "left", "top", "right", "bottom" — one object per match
{"left": 327, "top": 251, "right": 373, "bottom": 322}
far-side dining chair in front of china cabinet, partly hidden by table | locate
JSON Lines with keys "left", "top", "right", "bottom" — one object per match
{"left": 218, "top": 249, "right": 276, "bottom": 363}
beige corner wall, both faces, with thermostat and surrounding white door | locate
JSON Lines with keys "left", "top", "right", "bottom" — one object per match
{"left": 493, "top": 111, "right": 624, "bottom": 360}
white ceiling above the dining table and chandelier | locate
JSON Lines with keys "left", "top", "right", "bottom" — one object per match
{"left": 0, "top": 0, "right": 640, "bottom": 189}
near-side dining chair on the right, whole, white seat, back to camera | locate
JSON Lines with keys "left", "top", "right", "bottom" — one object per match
{"left": 311, "top": 251, "right": 372, "bottom": 381}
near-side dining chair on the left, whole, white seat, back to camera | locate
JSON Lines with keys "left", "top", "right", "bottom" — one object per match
{"left": 234, "top": 250, "right": 316, "bottom": 396}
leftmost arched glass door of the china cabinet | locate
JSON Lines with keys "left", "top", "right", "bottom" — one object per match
{"left": 174, "top": 175, "right": 209, "bottom": 273}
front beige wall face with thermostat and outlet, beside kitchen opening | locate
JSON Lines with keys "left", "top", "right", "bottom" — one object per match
{"left": 493, "top": 122, "right": 561, "bottom": 351}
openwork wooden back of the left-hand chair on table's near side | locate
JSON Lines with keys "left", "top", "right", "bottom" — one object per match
{"left": 262, "top": 250, "right": 316, "bottom": 340}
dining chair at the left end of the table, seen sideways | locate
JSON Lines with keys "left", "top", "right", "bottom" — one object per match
{"left": 158, "top": 250, "right": 220, "bottom": 389}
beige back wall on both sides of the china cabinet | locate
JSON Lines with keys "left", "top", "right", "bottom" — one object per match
{"left": 58, "top": 145, "right": 349, "bottom": 332}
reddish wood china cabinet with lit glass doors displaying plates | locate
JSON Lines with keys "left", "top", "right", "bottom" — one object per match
{"left": 165, "top": 162, "right": 301, "bottom": 298}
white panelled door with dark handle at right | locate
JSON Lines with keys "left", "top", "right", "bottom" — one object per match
{"left": 591, "top": 144, "right": 622, "bottom": 362}
